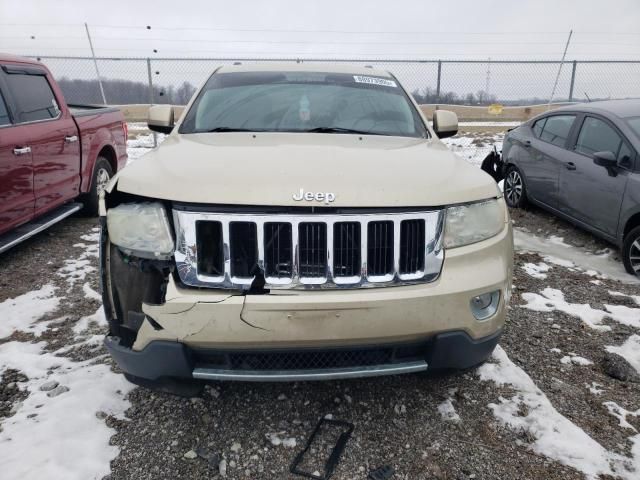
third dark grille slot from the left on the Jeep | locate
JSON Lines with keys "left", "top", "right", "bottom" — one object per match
{"left": 264, "top": 222, "right": 293, "bottom": 278}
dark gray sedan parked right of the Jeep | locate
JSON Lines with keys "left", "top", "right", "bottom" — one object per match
{"left": 502, "top": 100, "right": 640, "bottom": 276}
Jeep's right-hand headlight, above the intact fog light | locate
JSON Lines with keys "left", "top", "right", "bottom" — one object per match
{"left": 444, "top": 199, "right": 505, "bottom": 248}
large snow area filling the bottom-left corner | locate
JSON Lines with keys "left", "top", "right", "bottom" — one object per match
{"left": 0, "top": 342, "right": 133, "bottom": 480}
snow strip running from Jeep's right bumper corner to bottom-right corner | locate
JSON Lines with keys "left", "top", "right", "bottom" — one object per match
{"left": 478, "top": 346, "right": 640, "bottom": 480}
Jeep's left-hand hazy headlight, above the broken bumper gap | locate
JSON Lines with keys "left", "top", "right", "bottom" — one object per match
{"left": 107, "top": 202, "right": 173, "bottom": 258}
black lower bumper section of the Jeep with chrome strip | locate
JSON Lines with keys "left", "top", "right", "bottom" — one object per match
{"left": 105, "top": 330, "right": 502, "bottom": 382}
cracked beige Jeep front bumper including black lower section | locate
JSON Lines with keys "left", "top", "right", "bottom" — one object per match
{"left": 101, "top": 210, "right": 512, "bottom": 381}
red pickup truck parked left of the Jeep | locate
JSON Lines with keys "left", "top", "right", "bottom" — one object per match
{"left": 0, "top": 54, "right": 127, "bottom": 253}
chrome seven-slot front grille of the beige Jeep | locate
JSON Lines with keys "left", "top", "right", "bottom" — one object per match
{"left": 173, "top": 209, "right": 444, "bottom": 289}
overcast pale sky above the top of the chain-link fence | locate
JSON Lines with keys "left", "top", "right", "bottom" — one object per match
{"left": 0, "top": 0, "right": 640, "bottom": 59}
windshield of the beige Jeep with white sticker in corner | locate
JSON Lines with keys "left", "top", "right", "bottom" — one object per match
{"left": 180, "top": 72, "right": 427, "bottom": 137}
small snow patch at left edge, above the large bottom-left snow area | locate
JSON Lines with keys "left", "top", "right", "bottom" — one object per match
{"left": 0, "top": 285, "right": 60, "bottom": 338}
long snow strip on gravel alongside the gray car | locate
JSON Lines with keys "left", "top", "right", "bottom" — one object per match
{"left": 514, "top": 228, "right": 640, "bottom": 284}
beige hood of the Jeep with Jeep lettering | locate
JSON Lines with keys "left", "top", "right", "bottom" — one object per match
{"left": 114, "top": 132, "right": 499, "bottom": 207}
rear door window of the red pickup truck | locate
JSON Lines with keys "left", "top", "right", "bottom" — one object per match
{"left": 5, "top": 73, "right": 60, "bottom": 122}
